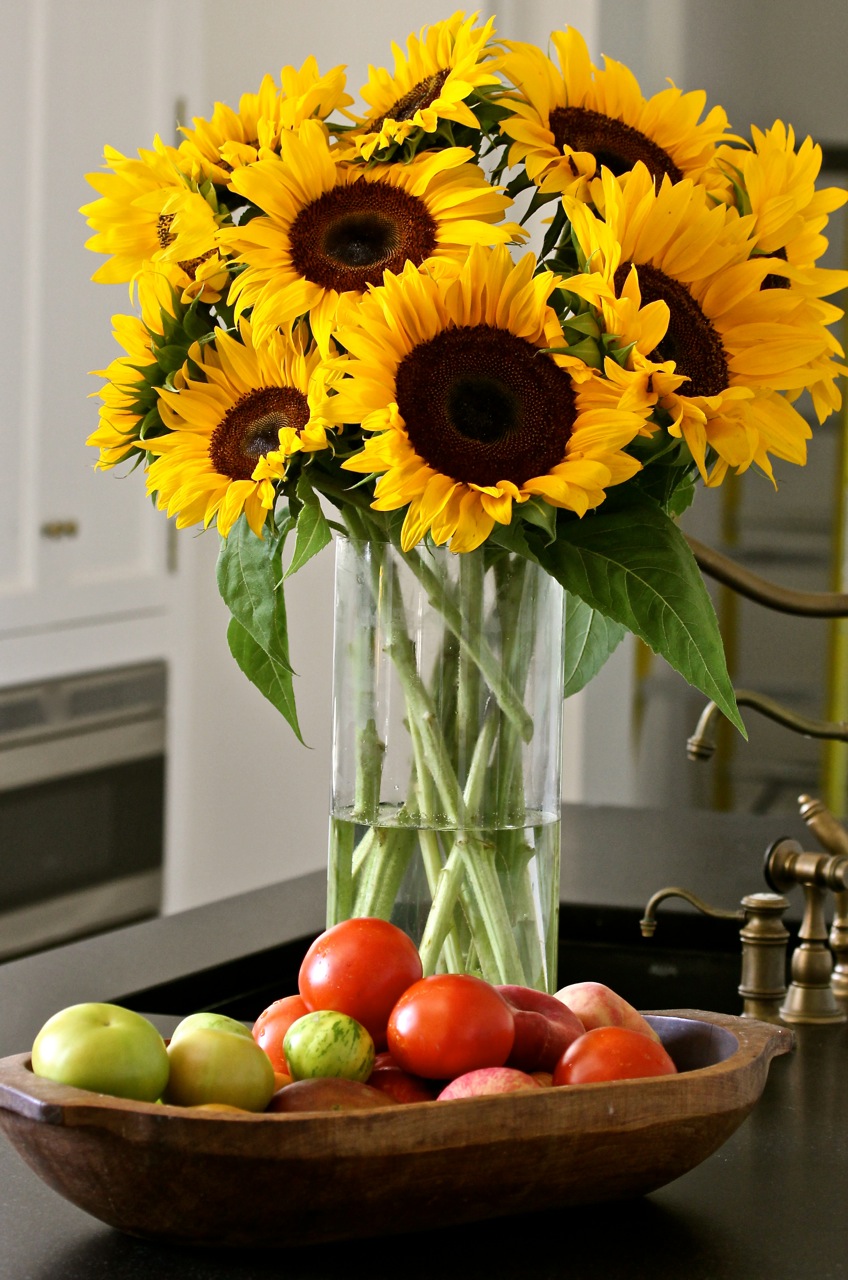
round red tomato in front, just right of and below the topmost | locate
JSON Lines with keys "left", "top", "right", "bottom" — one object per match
{"left": 388, "top": 973, "right": 515, "bottom": 1080}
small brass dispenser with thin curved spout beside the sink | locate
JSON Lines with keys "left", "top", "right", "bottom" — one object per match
{"left": 639, "top": 886, "right": 789, "bottom": 1023}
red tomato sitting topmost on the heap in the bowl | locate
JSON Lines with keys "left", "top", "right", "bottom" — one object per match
{"left": 297, "top": 916, "right": 421, "bottom": 1050}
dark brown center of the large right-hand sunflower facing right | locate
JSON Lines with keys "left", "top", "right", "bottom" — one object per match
{"left": 615, "top": 262, "right": 730, "bottom": 396}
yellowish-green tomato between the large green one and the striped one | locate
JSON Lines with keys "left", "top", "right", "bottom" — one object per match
{"left": 165, "top": 1024, "right": 277, "bottom": 1111}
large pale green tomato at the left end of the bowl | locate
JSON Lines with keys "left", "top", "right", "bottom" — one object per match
{"left": 32, "top": 1001, "right": 168, "bottom": 1102}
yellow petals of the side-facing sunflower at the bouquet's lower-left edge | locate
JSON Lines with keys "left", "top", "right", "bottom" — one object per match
{"left": 86, "top": 271, "right": 180, "bottom": 471}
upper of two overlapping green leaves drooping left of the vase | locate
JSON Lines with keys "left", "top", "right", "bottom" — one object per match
{"left": 218, "top": 515, "right": 292, "bottom": 675}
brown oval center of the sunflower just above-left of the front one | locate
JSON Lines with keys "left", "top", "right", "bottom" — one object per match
{"left": 289, "top": 178, "right": 437, "bottom": 293}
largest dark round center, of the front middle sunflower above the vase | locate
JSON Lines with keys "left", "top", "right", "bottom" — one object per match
{"left": 396, "top": 324, "right": 576, "bottom": 485}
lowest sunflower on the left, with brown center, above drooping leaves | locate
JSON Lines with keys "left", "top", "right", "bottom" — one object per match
{"left": 145, "top": 320, "right": 338, "bottom": 538}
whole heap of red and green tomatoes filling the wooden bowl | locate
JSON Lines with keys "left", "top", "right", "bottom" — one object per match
{"left": 26, "top": 918, "right": 701, "bottom": 1112}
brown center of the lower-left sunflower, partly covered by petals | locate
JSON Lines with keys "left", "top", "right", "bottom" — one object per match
{"left": 209, "top": 387, "right": 309, "bottom": 480}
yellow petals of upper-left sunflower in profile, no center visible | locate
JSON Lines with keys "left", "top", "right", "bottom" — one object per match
{"left": 179, "top": 55, "right": 354, "bottom": 186}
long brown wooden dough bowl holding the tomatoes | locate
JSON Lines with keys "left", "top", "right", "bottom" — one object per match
{"left": 0, "top": 1010, "right": 793, "bottom": 1247}
